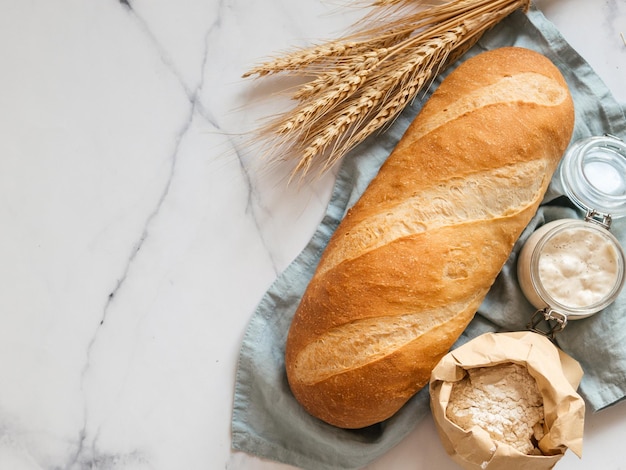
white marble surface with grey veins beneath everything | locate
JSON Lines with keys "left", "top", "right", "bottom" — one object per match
{"left": 0, "top": 0, "right": 626, "bottom": 470}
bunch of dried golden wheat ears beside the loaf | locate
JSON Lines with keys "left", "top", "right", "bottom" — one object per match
{"left": 244, "top": 0, "right": 530, "bottom": 182}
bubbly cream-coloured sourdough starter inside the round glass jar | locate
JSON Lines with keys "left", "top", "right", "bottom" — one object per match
{"left": 538, "top": 228, "right": 619, "bottom": 308}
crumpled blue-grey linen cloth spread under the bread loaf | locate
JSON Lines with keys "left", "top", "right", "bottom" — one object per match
{"left": 231, "top": 7, "right": 626, "bottom": 470}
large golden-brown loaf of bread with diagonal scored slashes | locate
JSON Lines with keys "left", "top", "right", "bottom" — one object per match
{"left": 285, "top": 47, "right": 574, "bottom": 429}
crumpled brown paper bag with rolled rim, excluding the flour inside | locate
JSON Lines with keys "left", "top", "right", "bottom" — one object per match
{"left": 430, "top": 332, "right": 585, "bottom": 470}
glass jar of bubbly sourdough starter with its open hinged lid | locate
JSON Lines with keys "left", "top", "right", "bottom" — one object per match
{"left": 517, "top": 135, "right": 626, "bottom": 337}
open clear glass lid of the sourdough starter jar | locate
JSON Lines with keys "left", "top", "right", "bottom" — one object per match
{"left": 560, "top": 135, "right": 626, "bottom": 218}
